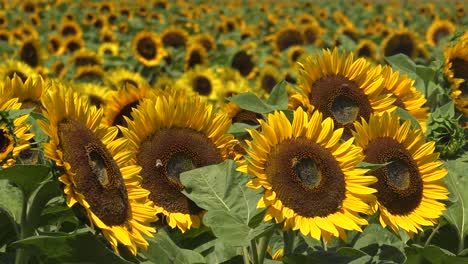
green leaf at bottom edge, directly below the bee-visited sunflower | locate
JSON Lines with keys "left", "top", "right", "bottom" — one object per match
{"left": 142, "top": 230, "right": 206, "bottom": 264}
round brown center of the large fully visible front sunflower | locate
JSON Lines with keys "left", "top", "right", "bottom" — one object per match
{"left": 265, "top": 138, "right": 346, "bottom": 217}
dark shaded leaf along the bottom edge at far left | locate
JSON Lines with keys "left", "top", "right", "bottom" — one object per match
{"left": 11, "top": 232, "right": 131, "bottom": 264}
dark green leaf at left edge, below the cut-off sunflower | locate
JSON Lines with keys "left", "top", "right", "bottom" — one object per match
{"left": 0, "top": 165, "right": 50, "bottom": 199}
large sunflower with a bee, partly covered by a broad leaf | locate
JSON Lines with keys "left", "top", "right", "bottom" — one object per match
{"left": 121, "top": 92, "right": 235, "bottom": 232}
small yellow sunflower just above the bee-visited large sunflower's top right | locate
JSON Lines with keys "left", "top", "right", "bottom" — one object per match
{"left": 175, "top": 67, "right": 223, "bottom": 101}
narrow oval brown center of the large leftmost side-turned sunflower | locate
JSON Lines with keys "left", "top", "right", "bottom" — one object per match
{"left": 58, "top": 119, "right": 130, "bottom": 226}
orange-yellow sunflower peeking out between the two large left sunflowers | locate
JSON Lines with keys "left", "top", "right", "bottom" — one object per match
{"left": 102, "top": 82, "right": 156, "bottom": 127}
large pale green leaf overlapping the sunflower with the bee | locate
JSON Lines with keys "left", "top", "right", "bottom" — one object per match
{"left": 180, "top": 160, "right": 273, "bottom": 246}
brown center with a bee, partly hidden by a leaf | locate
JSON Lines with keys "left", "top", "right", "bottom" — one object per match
{"left": 137, "top": 128, "right": 223, "bottom": 214}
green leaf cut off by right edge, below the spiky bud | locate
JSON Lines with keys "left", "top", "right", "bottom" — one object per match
{"left": 443, "top": 160, "right": 468, "bottom": 252}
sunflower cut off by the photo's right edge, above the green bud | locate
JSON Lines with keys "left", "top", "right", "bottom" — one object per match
{"left": 444, "top": 33, "right": 468, "bottom": 115}
